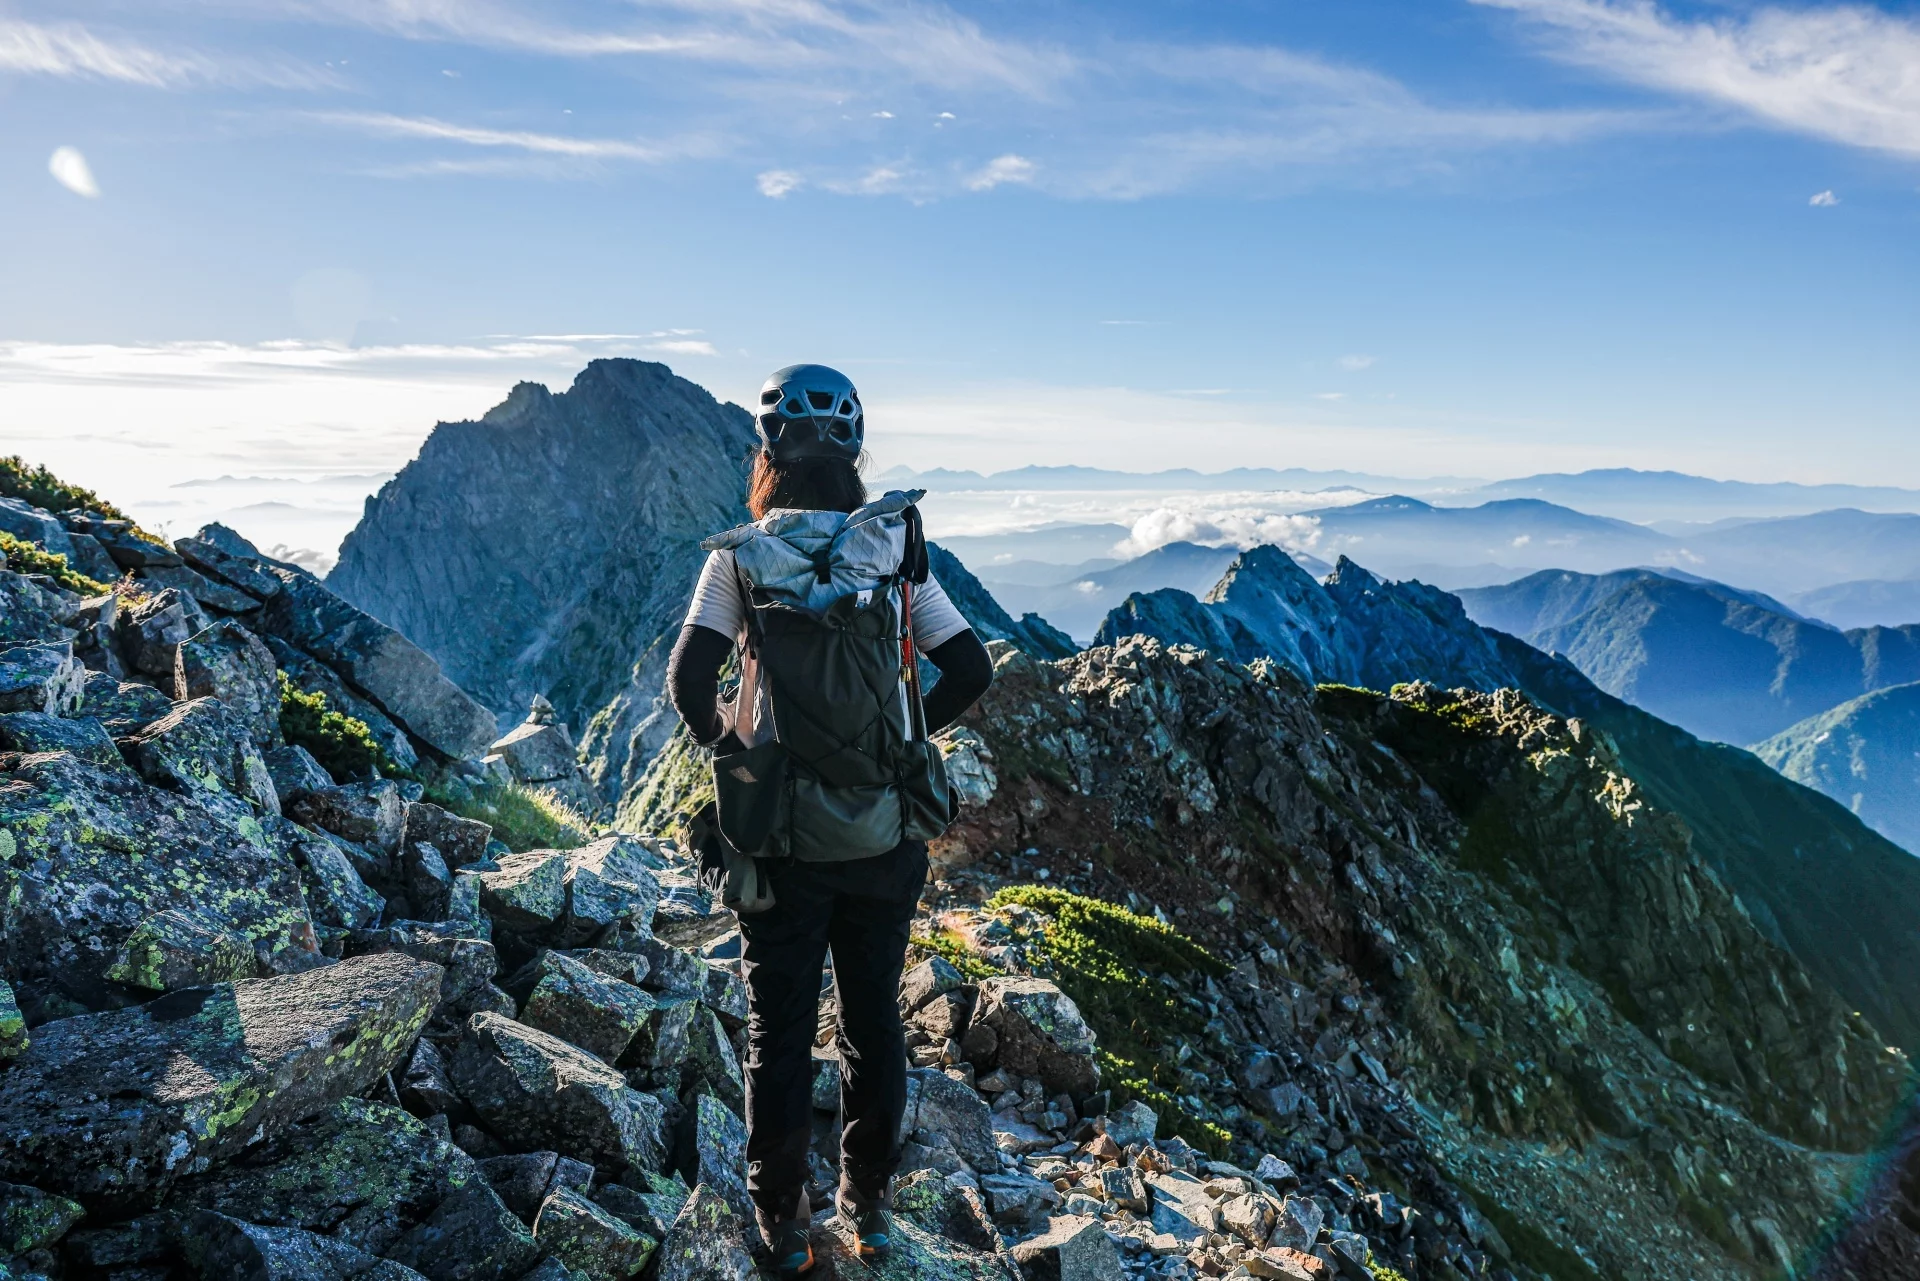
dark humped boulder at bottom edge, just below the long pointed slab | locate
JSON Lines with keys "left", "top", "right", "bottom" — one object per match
{"left": 167, "top": 1098, "right": 538, "bottom": 1281}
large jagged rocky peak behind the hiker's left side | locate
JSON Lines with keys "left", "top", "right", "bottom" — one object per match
{"left": 328, "top": 359, "right": 753, "bottom": 806}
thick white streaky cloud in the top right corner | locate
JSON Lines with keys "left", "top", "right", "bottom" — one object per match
{"left": 1475, "top": 0, "right": 1920, "bottom": 156}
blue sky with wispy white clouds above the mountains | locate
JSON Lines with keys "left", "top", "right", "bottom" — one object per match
{"left": 0, "top": 0, "right": 1920, "bottom": 553}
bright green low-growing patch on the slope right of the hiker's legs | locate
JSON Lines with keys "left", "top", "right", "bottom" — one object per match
{"left": 987, "top": 885, "right": 1233, "bottom": 1156}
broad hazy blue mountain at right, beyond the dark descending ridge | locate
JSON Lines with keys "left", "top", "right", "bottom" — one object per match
{"left": 1457, "top": 570, "right": 1920, "bottom": 743}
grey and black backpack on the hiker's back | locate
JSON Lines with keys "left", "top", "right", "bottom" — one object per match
{"left": 703, "top": 490, "right": 958, "bottom": 883}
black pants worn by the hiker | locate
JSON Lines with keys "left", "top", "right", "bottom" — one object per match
{"left": 739, "top": 841, "right": 927, "bottom": 1221}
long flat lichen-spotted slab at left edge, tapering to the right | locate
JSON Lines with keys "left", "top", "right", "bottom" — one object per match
{"left": 0, "top": 956, "right": 440, "bottom": 1208}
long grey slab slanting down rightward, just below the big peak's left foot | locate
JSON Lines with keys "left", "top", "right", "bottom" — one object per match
{"left": 259, "top": 567, "right": 495, "bottom": 761}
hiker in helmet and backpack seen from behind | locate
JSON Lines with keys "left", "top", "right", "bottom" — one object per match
{"left": 666, "top": 365, "right": 993, "bottom": 1277}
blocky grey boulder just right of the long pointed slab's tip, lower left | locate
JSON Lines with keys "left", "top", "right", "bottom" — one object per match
{"left": 447, "top": 1012, "right": 664, "bottom": 1170}
